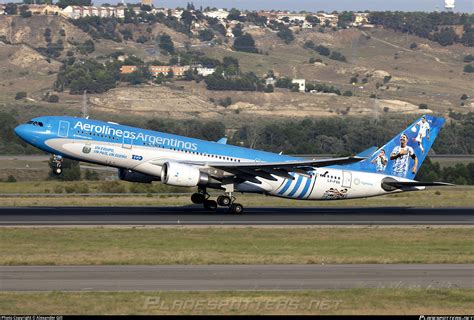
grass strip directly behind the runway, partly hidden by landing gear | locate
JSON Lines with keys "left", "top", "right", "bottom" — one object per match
{"left": 0, "top": 185, "right": 474, "bottom": 208}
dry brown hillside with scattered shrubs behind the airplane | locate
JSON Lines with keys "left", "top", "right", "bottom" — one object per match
{"left": 0, "top": 16, "right": 474, "bottom": 125}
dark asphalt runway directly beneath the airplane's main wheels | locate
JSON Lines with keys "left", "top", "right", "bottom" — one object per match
{"left": 0, "top": 206, "right": 474, "bottom": 226}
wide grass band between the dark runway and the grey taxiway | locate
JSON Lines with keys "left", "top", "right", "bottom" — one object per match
{"left": 0, "top": 227, "right": 474, "bottom": 265}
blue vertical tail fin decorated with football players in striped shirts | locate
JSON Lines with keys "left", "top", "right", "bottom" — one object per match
{"left": 344, "top": 115, "right": 445, "bottom": 180}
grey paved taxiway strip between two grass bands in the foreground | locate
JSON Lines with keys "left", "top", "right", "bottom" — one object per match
{"left": 0, "top": 264, "right": 474, "bottom": 291}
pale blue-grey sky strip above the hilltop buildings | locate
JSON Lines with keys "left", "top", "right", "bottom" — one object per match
{"left": 97, "top": 0, "right": 474, "bottom": 13}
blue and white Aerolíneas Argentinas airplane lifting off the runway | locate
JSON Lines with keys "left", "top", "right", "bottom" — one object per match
{"left": 15, "top": 115, "right": 450, "bottom": 214}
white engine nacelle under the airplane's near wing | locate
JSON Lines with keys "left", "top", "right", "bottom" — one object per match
{"left": 161, "top": 162, "right": 209, "bottom": 187}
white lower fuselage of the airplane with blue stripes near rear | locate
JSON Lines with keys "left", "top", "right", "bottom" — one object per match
{"left": 45, "top": 137, "right": 414, "bottom": 200}
